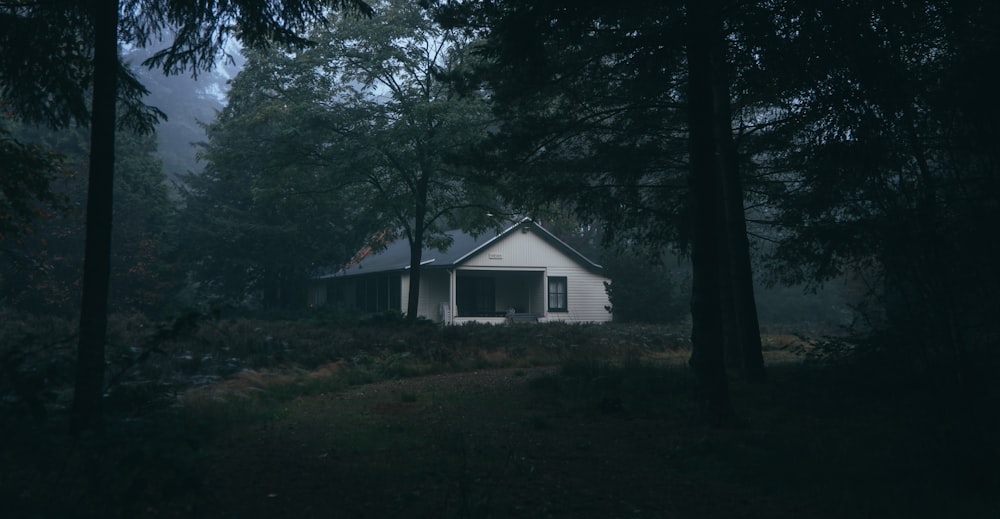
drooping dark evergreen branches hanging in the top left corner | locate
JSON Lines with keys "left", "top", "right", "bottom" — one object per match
{"left": 0, "top": 0, "right": 371, "bottom": 122}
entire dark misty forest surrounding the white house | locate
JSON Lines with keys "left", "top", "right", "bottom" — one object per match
{"left": 0, "top": 0, "right": 1000, "bottom": 474}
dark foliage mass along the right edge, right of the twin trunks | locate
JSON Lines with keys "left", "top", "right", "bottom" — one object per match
{"left": 759, "top": 1, "right": 1000, "bottom": 386}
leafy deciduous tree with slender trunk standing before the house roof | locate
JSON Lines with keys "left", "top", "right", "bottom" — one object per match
{"left": 196, "top": 2, "right": 495, "bottom": 318}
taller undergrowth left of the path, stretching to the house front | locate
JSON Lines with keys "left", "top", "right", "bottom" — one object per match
{"left": 0, "top": 310, "right": 696, "bottom": 517}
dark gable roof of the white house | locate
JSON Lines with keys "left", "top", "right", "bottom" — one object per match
{"left": 318, "top": 218, "right": 603, "bottom": 279}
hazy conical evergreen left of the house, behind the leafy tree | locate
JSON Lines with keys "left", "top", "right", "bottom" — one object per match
{"left": 181, "top": 45, "right": 370, "bottom": 308}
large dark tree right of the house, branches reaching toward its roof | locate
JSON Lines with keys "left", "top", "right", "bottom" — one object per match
{"left": 436, "top": 1, "right": 764, "bottom": 421}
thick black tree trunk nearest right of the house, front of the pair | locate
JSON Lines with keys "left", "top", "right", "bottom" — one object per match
{"left": 687, "top": 1, "right": 733, "bottom": 424}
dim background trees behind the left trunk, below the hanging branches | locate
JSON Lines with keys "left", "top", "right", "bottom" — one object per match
{"left": 0, "top": 126, "right": 177, "bottom": 315}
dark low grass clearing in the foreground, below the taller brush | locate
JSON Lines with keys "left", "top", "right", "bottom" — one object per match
{"left": 0, "top": 327, "right": 1000, "bottom": 519}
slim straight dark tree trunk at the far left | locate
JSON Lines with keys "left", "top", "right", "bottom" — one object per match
{"left": 70, "top": 0, "right": 118, "bottom": 433}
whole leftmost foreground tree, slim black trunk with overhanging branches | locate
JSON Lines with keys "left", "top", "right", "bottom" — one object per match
{"left": 0, "top": 0, "right": 371, "bottom": 432}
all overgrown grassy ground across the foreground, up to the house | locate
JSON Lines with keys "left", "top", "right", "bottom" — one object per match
{"left": 0, "top": 314, "right": 1000, "bottom": 517}
